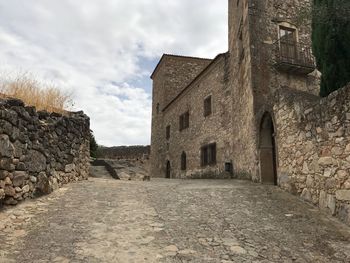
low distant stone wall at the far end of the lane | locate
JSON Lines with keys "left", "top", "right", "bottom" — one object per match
{"left": 97, "top": 145, "right": 151, "bottom": 159}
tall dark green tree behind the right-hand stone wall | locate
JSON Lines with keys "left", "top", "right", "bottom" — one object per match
{"left": 312, "top": 0, "right": 350, "bottom": 97}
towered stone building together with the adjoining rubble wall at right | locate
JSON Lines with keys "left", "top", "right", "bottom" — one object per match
{"left": 150, "top": 0, "right": 350, "bottom": 227}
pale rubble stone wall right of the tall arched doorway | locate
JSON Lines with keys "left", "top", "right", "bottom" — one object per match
{"left": 274, "top": 85, "right": 350, "bottom": 224}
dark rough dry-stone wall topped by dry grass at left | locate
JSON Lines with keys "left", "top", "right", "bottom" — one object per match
{"left": 0, "top": 99, "right": 90, "bottom": 205}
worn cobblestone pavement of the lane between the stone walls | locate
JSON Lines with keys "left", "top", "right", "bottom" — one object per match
{"left": 0, "top": 178, "right": 350, "bottom": 263}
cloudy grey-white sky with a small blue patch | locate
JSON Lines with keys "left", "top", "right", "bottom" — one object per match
{"left": 0, "top": 0, "right": 227, "bottom": 146}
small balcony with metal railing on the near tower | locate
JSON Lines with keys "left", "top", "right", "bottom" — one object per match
{"left": 275, "top": 41, "right": 316, "bottom": 75}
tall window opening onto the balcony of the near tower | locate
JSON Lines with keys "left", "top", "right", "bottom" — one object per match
{"left": 279, "top": 26, "right": 297, "bottom": 59}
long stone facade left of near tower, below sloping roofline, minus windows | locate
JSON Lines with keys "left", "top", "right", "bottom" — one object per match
{"left": 151, "top": 54, "right": 232, "bottom": 178}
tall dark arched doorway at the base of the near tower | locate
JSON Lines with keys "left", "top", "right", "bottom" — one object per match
{"left": 259, "top": 112, "right": 277, "bottom": 185}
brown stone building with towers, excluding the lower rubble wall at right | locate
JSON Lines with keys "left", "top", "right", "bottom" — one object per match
{"left": 151, "top": 0, "right": 317, "bottom": 183}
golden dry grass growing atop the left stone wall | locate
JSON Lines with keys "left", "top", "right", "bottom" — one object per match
{"left": 0, "top": 74, "right": 73, "bottom": 114}
